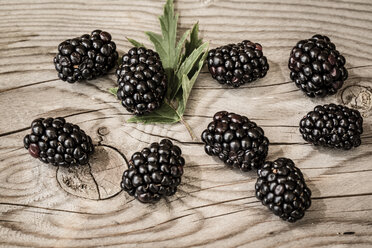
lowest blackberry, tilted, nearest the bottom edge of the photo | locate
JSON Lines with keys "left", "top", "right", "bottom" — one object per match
{"left": 255, "top": 158, "right": 311, "bottom": 222}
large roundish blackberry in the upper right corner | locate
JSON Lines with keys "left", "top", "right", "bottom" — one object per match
{"left": 288, "top": 34, "right": 348, "bottom": 97}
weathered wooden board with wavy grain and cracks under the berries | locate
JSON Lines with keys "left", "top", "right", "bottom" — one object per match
{"left": 0, "top": 0, "right": 372, "bottom": 247}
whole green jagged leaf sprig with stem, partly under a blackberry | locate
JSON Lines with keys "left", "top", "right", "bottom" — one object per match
{"left": 110, "top": 0, "right": 209, "bottom": 138}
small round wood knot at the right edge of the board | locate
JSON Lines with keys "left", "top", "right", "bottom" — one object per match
{"left": 341, "top": 85, "right": 372, "bottom": 113}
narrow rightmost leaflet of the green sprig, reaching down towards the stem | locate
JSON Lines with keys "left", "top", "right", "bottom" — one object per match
{"left": 177, "top": 43, "right": 209, "bottom": 116}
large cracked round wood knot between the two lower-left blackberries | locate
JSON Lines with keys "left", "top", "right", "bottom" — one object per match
{"left": 56, "top": 145, "right": 128, "bottom": 200}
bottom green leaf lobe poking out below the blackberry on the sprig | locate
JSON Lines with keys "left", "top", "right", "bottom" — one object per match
{"left": 127, "top": 102, "right": 180, "bottom": 124}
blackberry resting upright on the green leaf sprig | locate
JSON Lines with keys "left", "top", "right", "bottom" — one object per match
{"left": 116, "top": 47, "right": 167, "bottom": 115}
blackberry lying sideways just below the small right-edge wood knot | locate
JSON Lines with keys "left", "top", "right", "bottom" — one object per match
{"left": 300, "top": 104, "right": 363, "bottom": 150}
